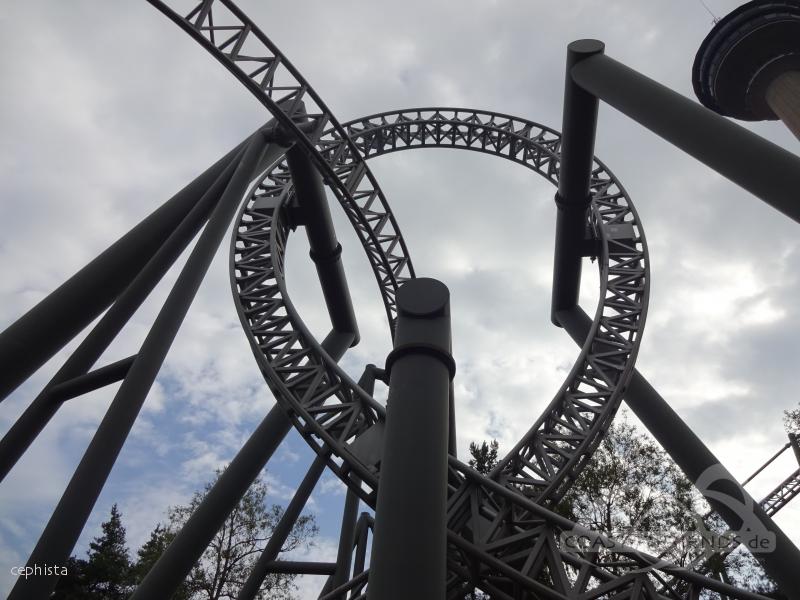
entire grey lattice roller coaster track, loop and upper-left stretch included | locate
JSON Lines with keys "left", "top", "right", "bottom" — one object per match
{"left": 144, "top": 0, "right": 776, "bottom": 600}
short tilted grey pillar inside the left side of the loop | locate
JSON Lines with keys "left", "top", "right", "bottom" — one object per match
{"left": 286, "top": 144, "right": 359, "bottom": 346}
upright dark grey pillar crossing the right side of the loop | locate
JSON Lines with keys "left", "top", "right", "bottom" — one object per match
{"left": 550, "top": 40, "right": 604, "bottom": 325}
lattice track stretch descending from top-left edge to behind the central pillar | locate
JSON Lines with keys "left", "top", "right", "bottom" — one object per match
{"left": 147, "top": 0, "right": 414, "bottom": 332}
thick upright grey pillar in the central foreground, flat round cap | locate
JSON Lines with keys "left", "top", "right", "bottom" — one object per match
{"left": 367, "top": 279, "right": 455, "bottom": 600}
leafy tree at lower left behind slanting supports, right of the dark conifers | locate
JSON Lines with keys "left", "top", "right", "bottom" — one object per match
{"left": 136, "top": 471, "right": 318, "bottom": 600}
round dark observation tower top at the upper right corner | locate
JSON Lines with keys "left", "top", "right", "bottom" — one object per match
{"left": 692, "top": 0, "right": 800, "bottom": 139}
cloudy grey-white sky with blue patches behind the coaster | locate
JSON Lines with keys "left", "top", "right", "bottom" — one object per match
{"left": 0, "top": 0, "right": 800, "bottom": 598}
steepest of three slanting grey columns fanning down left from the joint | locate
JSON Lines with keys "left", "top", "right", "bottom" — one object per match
{"left": 9, "top": 133, "right": 272, "bottom": 600}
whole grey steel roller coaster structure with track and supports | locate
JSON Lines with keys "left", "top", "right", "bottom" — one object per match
{"left": 0, "top": 0, "right": 800, "bottom": 600}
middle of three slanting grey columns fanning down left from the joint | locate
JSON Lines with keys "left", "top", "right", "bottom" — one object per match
{"left": 0, "top": 149, "right": 244, "bottom": 481}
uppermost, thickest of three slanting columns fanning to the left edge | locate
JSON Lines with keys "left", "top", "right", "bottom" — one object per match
{"left": 0, "top": 130, "right": 278, "bottom": 401}
